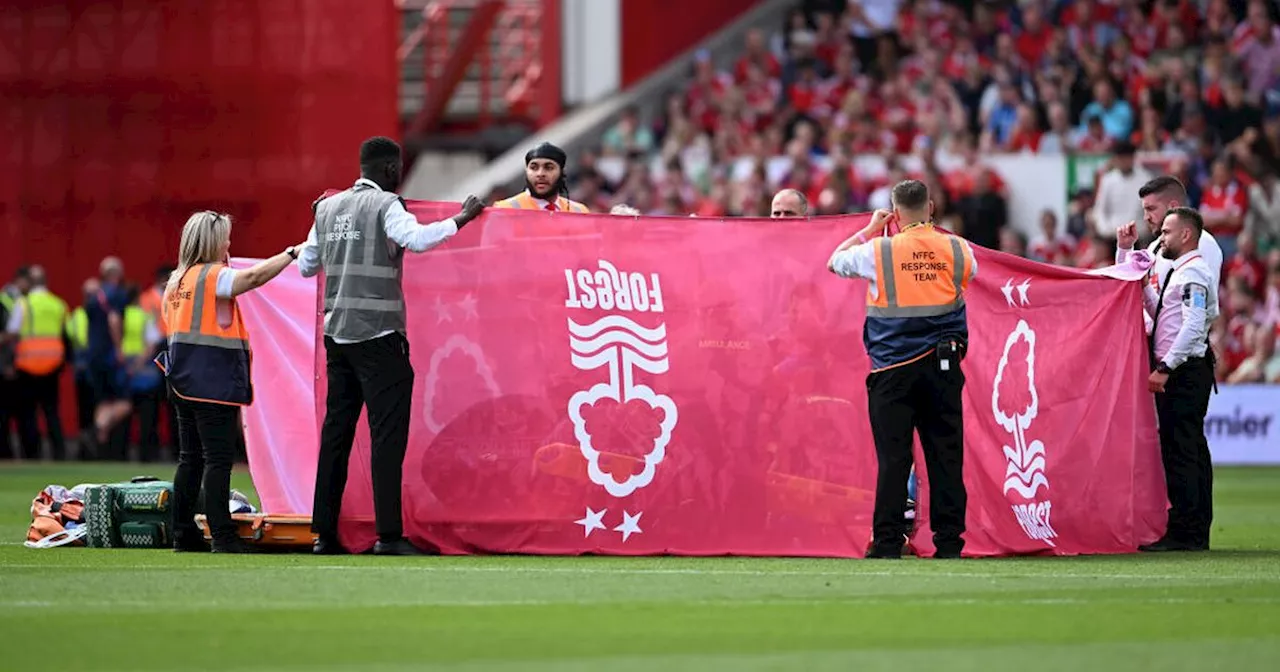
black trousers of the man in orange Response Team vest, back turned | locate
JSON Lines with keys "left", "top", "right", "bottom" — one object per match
{"left": 867, "top": 353, "right": 968, "bottom": 552}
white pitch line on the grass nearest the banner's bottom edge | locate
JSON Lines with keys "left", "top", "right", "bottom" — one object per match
{"left": 0, "top": 561, "right": 1280, "bottom": 582}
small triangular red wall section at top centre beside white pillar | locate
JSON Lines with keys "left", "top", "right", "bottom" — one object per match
{"left": 621, "top": 0, "right": 759, "bottom": 87}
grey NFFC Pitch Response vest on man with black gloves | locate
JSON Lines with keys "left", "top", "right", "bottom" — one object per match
{"left": 315, "top": 184, "right": 404, "bottom": 342}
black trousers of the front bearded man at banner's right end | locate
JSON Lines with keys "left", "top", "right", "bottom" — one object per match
{"left": 1156, "top": 357, "right": 1213, "bottom": 545}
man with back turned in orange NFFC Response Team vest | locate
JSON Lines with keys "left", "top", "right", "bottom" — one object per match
{"left": 827, "top": 179, "right": 978, "bottom": 558}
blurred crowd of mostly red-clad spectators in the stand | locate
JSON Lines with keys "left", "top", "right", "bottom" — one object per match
{"left": 572, "top": 0, "right": 1280, "bottom": 383}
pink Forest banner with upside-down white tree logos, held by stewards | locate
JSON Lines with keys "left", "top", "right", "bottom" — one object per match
{"left": 242, "top": 202, "right": 1165, "bottom": 557}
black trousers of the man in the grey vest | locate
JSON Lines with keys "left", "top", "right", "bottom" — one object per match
{"left": 311, "top": 334, "right": 413, "bottom": 541}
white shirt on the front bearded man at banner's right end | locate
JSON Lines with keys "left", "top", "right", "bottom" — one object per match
{"left": 1142, "top": 250, "right": 1217, "bottom": 369}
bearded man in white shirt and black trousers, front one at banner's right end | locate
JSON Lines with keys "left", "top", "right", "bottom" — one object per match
{"left": 1140, "top": 207, "right": 1217, "bottom": 552}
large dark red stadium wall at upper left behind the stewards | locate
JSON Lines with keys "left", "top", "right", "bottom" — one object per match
{"left": 0, "top": 0, "right": 399, "bottom": 437}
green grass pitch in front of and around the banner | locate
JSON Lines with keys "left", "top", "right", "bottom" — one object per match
{"left": 0, "top": 463, "right": 1280, "bottom": 672}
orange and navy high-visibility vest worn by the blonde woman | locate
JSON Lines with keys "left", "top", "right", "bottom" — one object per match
{"left": 156, "top": 264, "right": 253, "bottom": 406}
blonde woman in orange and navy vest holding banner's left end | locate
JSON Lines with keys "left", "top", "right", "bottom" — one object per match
{"left": 156, "top": 210, "right": 297, "bottom": 553}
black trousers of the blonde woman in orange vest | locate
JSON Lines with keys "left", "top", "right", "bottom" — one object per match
{"left": 173, "top": 389, "right": 244, "bottom": 544}
